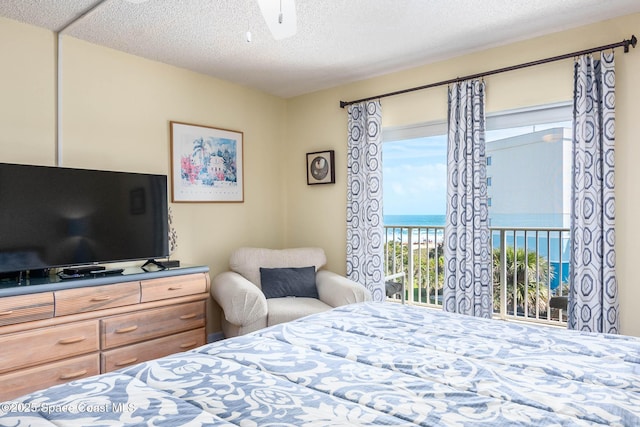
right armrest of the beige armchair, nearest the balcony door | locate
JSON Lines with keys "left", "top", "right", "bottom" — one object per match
{"left": 316, "top": 270, "right": 372, "bottom": 307}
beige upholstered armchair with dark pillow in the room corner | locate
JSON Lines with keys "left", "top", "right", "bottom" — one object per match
{"left": 211, "top": 248, "right": 371, "bottom": 338}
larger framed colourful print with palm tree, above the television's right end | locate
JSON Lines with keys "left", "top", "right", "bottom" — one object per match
{"left": 170, "top": 121, "right": 244, "bottom": 203}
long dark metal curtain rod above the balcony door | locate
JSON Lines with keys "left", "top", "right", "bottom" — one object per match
{"left": 340, "top": 35, "right": 638, "bottom": 108}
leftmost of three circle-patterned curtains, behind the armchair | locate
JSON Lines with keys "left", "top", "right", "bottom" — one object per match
{"left": 347, "top": 100, "right": 385, "bottom": 301}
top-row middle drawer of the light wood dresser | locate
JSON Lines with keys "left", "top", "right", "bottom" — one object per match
{"left": 55, "top": 282, "right": 140, "bottom": 316}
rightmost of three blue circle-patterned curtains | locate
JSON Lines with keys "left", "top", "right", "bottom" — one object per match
{"left": 568, "top": 52, "right": 619, "bottom": 333}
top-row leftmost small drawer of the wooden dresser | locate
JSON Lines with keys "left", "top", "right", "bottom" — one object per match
{"left": 0, "top": 292, "right": 53, "bottom": 326}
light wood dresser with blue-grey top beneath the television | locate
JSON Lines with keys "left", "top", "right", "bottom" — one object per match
{"left": 0, "top": 267, "right": 209, "bottom": 402}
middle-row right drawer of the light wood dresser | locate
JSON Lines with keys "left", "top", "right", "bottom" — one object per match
{"left": 100, "top": 301, "right": 205, "bottom": 350}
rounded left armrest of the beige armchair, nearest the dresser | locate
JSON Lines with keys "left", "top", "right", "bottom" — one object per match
{"left": 211, "top": 271, "right": 267, "bottom": 326}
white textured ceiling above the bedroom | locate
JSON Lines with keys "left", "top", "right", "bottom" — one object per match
{"left": 0, "top": 0, "right": 640, "bottom": 98}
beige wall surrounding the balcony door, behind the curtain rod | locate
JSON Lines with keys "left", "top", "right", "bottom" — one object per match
{"left": 285, "top": 14, "right": 640, "bottom": 336}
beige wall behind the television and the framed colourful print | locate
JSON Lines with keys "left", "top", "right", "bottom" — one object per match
{"left": 0, "top": 18, "right": 286, "bottom": 332}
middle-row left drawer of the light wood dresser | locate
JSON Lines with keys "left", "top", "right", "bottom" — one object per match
{"left": 0, "top": 320, "right": 99, "bottom": 372}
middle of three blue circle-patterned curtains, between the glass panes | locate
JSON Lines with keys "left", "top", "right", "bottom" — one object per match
{"left": 443, "top": 80, "right": 493, "bottom": 318}
